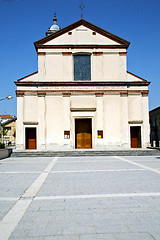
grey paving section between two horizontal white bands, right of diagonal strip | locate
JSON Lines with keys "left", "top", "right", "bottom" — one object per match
{"left": 38, "top": 171, "right": 160, "bottom": 196}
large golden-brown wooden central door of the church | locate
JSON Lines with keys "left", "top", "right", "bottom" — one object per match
{"left": 75, "top": 119, "right": 92, "bottom": 148}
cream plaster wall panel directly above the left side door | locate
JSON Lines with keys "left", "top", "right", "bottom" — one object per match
{"left": 24, "top": 95, "right": 38, "bottom": 122}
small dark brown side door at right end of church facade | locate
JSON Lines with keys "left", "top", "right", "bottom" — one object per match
{"left": 130, "top": 127, "right": 141, "bottom": 148}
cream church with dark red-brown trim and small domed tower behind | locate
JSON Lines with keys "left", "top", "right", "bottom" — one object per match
{"left": 15, "top": 16, "right": 149, "bottom": 150}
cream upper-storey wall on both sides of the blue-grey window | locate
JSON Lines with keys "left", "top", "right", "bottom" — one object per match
{"left": 38, "top": 51, "right": 127, "bottom": 81}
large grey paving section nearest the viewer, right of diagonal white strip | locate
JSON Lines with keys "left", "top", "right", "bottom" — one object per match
{"left": 10, "top": 197, "right": 160, "bottom": 239}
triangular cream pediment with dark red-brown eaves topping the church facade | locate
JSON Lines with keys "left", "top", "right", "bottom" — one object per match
{"left": 34, "top": 19, "right": 130, "bottom": 48}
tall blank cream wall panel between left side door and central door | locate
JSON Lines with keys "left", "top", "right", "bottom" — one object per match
{"left": 45, "top": 95, "right": 64, "bottom": 149}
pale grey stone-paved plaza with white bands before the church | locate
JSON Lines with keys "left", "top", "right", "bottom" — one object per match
{"left": 0, "top": 156, "right": 160, "bottom": 240}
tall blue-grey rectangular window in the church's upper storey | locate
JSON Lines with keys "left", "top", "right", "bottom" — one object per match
{"left": 74, "top": 55, "right": 91, "bottom": 81}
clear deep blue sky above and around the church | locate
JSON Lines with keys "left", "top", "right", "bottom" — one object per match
{"left": 0, "top": 0, "right": 160, "bottom": 115}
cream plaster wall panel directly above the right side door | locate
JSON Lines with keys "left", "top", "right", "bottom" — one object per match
{"left": 128, "top": 94, "right": 142, "bottom": 121}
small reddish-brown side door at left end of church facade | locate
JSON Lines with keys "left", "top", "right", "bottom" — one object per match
{"left": 26, "top": 128, "right": 37, "bottom": 149}
